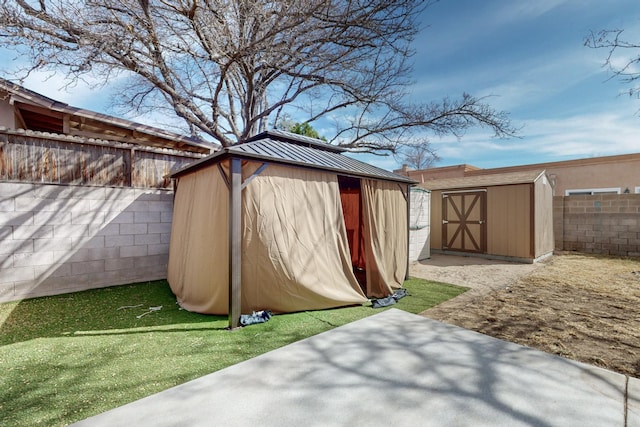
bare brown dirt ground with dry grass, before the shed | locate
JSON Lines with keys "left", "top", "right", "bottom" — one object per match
{"left": 411, "top": 253, "right": 640, "bottom": 377}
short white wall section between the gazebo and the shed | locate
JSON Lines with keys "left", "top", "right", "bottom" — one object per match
{"left": 409, "top": 188, "right": 431, "bottom": 261}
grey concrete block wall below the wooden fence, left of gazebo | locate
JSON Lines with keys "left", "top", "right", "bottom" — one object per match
{"left": 0, "top": 182, "right": 173, "bottom": 302}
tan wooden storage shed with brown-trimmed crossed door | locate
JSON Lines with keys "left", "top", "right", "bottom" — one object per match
{"left": 420, "top": 171, "right": 554, "bottom": 262}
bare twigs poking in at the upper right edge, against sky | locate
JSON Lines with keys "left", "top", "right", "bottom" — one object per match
{"left": 584, "top": 30, "right": 640, "bottom": 96}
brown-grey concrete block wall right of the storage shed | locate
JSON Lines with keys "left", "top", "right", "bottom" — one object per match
{"left": 553, "top": 194, "right": 640, "bottom": 257}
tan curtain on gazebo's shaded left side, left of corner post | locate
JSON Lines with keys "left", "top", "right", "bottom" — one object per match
{"left": 167, "top": 166, "right": 229, "bottom": 314}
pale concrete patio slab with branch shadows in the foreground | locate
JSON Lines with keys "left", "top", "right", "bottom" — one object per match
{"left": 76, "top": 309, "right": 628, "bottom": 427}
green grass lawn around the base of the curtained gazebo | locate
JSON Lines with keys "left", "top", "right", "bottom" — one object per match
{"left": 0, "top": 279, "right": 466, "bottom": 426}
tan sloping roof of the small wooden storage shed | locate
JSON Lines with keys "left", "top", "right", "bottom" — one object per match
{"left": 419, "top": 170, "right": 545, "bottom": 190}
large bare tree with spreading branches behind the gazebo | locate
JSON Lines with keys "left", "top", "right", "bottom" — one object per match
{"left": 0, "top": 0, "right": 516, "bottom": 152}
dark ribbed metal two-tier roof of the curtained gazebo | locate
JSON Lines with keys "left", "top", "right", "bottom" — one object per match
{"left": 171, "top": 131, "right": 416, "bottom": 184}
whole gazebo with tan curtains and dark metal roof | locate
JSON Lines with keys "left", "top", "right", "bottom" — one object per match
{"left": 168, "top": 131, "right": 413, "bottom": 327}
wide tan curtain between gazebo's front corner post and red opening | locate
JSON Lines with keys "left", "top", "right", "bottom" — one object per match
{"left": 242, "top": 165, "right": 366, "bottom": 312}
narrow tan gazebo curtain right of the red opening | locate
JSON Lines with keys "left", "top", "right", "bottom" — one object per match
{"left": 362, "top": 179, "right": 408, "bottom": 298}
